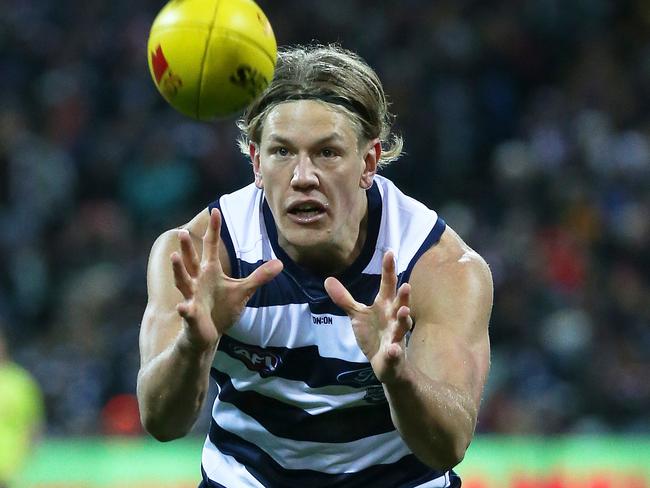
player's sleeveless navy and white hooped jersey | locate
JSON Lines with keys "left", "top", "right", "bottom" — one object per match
{"left": 201, "top": 176, "right": 460, "bottom": 488}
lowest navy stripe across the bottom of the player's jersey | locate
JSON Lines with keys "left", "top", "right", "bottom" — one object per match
{"left": 209, "top": 420, "right": 450, "bottom": 488}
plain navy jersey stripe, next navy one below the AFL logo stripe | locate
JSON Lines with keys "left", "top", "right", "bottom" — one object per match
{"left": 211, "top": 369, "right": 395, "bottom": 443}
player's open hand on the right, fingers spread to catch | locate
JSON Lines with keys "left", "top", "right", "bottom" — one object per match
{"left": 325, "top": 251, "right": 413, "bottom": 383}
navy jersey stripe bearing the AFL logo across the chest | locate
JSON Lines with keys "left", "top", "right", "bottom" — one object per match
{"left": 219, "top": 334, "right": 374, "bottom": 388}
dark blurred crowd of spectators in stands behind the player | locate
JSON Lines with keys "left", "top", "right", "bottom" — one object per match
{"left": 0, "top": 0, "right": 650, "bottom": 435}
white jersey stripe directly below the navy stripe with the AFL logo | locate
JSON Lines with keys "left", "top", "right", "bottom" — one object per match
{"left": 214, "top": 351, "right": 368, "bottom": 415}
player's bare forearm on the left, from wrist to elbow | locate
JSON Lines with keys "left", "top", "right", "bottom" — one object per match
{"left": 137, "top": 334, "right": 215, "bottom": 442}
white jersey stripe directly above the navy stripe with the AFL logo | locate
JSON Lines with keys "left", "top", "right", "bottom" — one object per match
{"left": 228, "top": 303, "right": 368, "bottom": 363}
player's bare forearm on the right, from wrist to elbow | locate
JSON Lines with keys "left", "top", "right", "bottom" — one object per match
{"left": 383, "top": 362, "right": 477, "bottom": 469}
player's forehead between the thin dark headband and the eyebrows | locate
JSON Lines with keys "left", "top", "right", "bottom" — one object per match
{"left": 260, "top": 100, "right": 359, "bottom": 146}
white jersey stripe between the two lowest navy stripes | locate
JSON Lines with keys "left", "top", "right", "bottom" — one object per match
{"left": 212, "top": 401, "right": 408, "bottom": 472}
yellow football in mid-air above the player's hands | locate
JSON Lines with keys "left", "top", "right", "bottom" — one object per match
{"left": 148, "top": 0, "right": 277, "bottom": 120}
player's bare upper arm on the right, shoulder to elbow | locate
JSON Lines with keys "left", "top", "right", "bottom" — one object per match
{"left": 408, "top": 234, "right": 492, "bottom": 411}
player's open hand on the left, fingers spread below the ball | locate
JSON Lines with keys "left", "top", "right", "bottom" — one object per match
{"left": 170, "top": 209, "right": 283, "bottom": 350}
